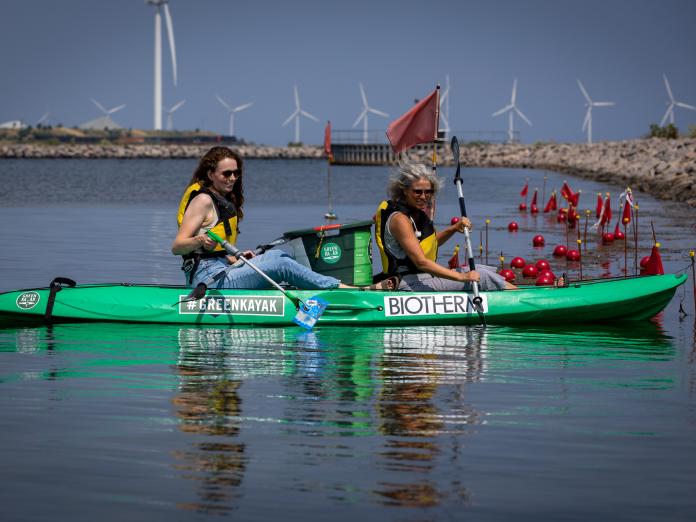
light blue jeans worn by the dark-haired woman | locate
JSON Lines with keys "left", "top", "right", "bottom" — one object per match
{"left": 191, "top": 250, "right": 340, "bottom": 290}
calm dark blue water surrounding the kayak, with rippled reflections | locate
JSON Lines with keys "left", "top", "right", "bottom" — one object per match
{"left": 0, "top": 156, "right": 696, "bottom": 521}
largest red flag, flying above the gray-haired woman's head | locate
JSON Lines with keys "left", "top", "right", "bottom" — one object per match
{"left": 387, "top": 89, "right": 440, "bottom": 152}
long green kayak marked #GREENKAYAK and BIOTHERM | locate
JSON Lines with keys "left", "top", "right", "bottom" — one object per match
{"left": 0, "top": 275, "right": 686, "bottom": 327}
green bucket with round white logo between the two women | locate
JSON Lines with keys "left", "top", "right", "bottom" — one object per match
{"left": 283, "top": 220, "right": 372, "bottom": 286}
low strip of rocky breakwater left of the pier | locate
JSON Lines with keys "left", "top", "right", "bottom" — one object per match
{"left": 0, "top": 143, "right": 323, "bottom": 159}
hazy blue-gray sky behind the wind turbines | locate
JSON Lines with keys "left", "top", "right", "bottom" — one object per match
{"left": 0, "top": 0, "right": 696, "bottom": 145}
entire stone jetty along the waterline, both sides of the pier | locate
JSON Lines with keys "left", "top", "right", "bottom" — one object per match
{"left": 0, "top": 138, "right": 696, "bottom": 207}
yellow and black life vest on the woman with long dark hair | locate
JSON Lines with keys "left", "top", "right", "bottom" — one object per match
{"left": 176, "top": 183, "right": 239, "bottom": 281}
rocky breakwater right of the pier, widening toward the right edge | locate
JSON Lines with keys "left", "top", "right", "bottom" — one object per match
{"left": 446, "top": 138, "right": 696, "bottom": 207}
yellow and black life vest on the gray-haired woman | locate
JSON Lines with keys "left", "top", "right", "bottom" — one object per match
{"left": 375, "top": 200, "right": 437, "bottom": 275}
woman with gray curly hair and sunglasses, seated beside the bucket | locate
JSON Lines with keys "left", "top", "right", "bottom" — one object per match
{"left": 375, "top": 163, "right": 516, "bottom": 291}
